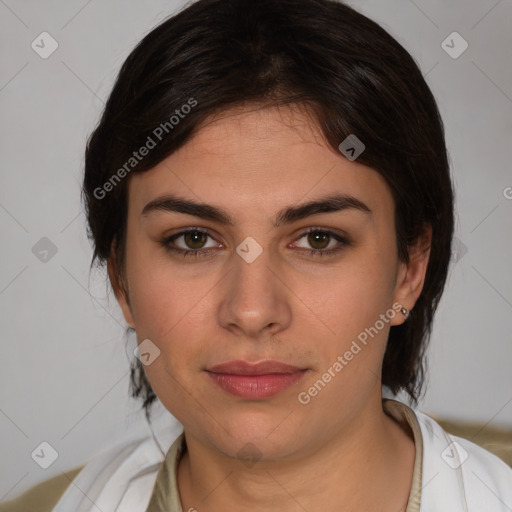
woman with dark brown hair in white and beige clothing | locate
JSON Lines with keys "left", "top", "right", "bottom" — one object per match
{"left": 5, "top": 0, "right": 512, "bottom": 512}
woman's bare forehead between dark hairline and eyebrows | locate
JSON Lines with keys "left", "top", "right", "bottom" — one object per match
{"left": 130, "top": 107, "right": 392, "bottom": 220}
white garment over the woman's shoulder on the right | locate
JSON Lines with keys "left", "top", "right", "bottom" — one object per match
{"left": 414, "top": 411, "right": 512, "bottom": 512}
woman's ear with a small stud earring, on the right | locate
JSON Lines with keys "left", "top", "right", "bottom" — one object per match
{"left": 391, "top": 225, "right": 432, "bottom": 325}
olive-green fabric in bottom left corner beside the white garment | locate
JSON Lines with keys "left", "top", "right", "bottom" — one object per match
{"left": 0, "top": 465, "right": 85, "bottom": 512}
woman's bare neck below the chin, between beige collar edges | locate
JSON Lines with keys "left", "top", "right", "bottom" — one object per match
{"left": 178, "top": 395, "right": 415, "bottom": 512}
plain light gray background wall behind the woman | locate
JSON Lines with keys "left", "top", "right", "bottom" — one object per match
{"left": 0, "top": 0, "right": 512, "bottom": 499}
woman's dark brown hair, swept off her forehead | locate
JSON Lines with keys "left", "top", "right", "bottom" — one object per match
{"left": 83, "top": 0, "right": 453, "bottom": 419}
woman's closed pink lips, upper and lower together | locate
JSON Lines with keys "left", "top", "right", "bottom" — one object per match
{"left": 206, "top": 361, "right": 307, "bottom": 400}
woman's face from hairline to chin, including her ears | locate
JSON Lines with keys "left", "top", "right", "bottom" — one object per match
{"left": 111, "top": 107, "right": 426, "bottom": 459}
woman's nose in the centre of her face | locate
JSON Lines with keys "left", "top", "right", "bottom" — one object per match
{"left": 218, "top": 245, "right": 292, "bottom": 339}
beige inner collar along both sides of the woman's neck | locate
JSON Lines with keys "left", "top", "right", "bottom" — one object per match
{"left": 146, "top": 399, "right": 423, "bottom": 512}
